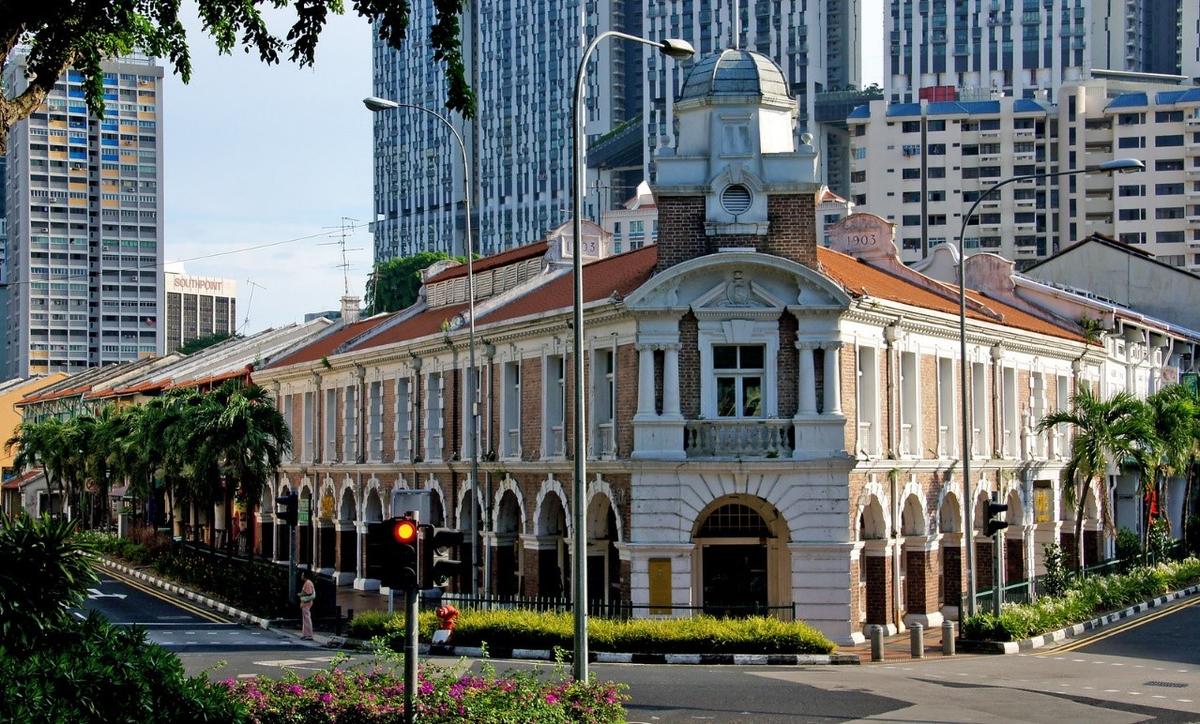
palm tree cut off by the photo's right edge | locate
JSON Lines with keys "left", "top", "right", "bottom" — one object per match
{"left": 1146, "top": 384, "right": 1200, "bottom": 540}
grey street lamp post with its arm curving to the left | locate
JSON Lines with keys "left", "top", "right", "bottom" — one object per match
{"left": 362, "top": 96, "right": 481, "bottom": 596}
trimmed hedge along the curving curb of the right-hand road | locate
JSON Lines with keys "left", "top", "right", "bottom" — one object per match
{"left": 962, "top": 558, "right": 1200, "bottom": 641}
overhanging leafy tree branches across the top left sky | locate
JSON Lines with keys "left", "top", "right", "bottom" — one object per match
{"left": 0, "top": 0, "right": 475, "bottom": 155}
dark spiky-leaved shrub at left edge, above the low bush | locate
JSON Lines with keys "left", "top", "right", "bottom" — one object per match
{"left": 0, "top": 515, "right": 98, "bottom": 658}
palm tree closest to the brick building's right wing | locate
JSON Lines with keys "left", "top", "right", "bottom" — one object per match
{"left": 1038, "top": 385, "right": 1153, "bottom": 568}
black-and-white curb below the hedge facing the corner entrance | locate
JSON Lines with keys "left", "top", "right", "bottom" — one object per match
{"left": 325, "top": 636, "right": 860, "bottom": 666}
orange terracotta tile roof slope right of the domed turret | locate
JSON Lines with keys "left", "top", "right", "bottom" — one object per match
{"left": 817, "top": 249, "right": 1084, "bottom": 342}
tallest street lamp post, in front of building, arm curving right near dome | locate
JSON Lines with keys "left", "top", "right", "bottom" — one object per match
{"left": 571, "top": 30, "right": 696, "bottom": 681}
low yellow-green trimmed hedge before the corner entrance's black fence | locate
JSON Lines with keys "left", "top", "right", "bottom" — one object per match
{"left": 349, "top": 609, "right": 835, "bottom": 653}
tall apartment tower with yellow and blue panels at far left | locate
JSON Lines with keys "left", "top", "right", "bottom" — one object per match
{"left": 5, "top": 55, "right": 163, "bottom": 377}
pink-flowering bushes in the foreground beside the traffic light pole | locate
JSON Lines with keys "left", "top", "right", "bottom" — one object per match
{"left": 223, "top": 656, "right": 629, "bottom": 724}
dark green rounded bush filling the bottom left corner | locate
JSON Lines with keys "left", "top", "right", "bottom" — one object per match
{"left": 0, "top": 615, "right": 246, "bottom": 723}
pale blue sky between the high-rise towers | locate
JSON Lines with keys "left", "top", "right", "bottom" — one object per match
{"left": 163, "top": 0, "right": 883, "bottom": 331}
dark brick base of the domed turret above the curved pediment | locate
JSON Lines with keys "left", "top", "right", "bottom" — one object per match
{"left": 655, "top": 193, "right": 817, "bottom": 271}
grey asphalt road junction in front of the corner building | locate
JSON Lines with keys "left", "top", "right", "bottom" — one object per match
{"left": 88, "top": 575, "right": 1200, "bottom": 724}
